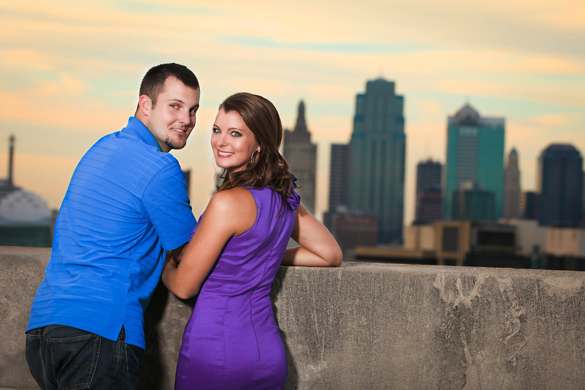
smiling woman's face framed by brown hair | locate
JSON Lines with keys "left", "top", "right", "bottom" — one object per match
{"left": 211, "top": 108, "right": 260, "bottom": 172}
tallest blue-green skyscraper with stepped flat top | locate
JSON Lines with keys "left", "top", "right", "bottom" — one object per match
{"left": 349, "top": 78, "right": 406, "bottom": 243}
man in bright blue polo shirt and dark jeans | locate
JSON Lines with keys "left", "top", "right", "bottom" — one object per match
{"left": 26, "top": 64, "right": 200, "bottom": 389}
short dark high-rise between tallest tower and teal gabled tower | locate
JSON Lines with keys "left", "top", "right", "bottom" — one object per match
{"left": 414, "top": 159, "right": 443, "bottom": 224}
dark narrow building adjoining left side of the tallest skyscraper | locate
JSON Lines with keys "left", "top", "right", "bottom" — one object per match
{"left": 329, "top": 144, "right": 349, "bottom": 212}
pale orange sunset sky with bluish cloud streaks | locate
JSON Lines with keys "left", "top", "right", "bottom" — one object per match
{"left": 0, "top": 0, "right": 585, "bottom": 224}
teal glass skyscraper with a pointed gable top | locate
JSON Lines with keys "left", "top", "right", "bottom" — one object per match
{"left": 444, "top": 104, "right": 505, "bottom": 219}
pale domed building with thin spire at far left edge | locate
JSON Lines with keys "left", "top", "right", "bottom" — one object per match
{"left": 0, "top": 135, "right": 52, "bottom": 247}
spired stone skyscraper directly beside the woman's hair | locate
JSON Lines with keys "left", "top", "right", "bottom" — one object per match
{"left": 283, "top": 101, "right": 317, "bottom": 214}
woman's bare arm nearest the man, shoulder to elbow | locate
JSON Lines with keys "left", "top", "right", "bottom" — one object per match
{"left": 162, "top": 187, "right": 257, "bottom": 299}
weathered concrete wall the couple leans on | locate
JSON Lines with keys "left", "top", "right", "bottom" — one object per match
{"left": 0, "top": 248, "right": 585, "bottom": 390}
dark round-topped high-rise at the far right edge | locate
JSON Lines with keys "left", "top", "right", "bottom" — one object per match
{"left": 538, "top": 144, "right": 583, "bottom": 226}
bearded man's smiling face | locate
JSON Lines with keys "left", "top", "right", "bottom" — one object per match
{"left": 148, "top": 76, "right": 199, "bottom": 152}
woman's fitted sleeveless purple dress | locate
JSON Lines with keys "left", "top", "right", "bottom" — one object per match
{"left": 175, "top": 187, "right": 300, "bottom": 390}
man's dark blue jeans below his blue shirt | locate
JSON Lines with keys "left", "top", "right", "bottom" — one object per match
{"left": 26, "top": 325, "right": 144, "bottom": 390}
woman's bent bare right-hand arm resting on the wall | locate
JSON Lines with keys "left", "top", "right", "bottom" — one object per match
{"left": 282, "top": 204, "right": 343, "bottom": 267}
